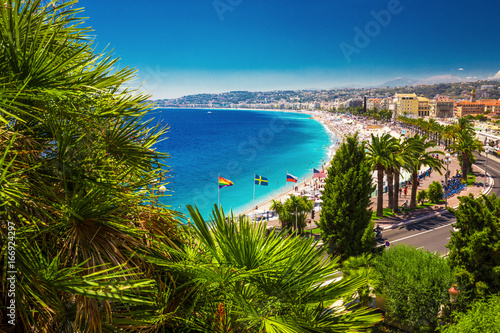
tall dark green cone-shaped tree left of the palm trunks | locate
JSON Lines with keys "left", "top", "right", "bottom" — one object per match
{"left": 319, "top": 133, "right": 375, "bottom": 260}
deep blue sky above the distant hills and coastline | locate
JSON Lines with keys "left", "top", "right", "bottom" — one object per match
{"left": 79, "top": 0, "right": 500, "bottom": 98}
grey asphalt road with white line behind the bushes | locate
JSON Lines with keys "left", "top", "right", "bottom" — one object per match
{"left": 379, "top": 156, "right": 500, "bottom": 255}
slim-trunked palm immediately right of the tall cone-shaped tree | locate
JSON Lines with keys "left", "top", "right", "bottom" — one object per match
{"left": 367, "top": 134, "right": 397, "bottom": 217}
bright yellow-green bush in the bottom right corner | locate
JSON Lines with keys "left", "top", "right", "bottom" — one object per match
{"left": 442, "top": 295, "right": 500, "bottom": 333}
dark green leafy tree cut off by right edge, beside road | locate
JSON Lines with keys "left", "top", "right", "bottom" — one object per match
{"left": 447, "top": 194, "right": 500, "bottom": 303}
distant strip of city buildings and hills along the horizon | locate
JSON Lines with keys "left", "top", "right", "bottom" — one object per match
{"left": 155, "top": 81, "right": 500, "bottom": 119}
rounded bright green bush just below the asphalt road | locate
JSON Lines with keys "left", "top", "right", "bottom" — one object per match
{"left": 375, "top": 245, "right": 453, "bottom": 331}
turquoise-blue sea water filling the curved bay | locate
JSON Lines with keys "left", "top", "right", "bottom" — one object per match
{"left": 148, "top": 108, "right": 337, "bottom": 219}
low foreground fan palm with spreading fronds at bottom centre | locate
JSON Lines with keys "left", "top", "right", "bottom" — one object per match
{"left": 150, "top": 206, "right": 380, "bottom": 332}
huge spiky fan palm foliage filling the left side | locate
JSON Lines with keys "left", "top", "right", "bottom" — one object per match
{"left": 0, "top": 0, "right": 182, "bottom": 332}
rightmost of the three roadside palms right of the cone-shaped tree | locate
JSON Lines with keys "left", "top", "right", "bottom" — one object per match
{"left": 408, "top": 134, "right": 443, "bottom": 208}
